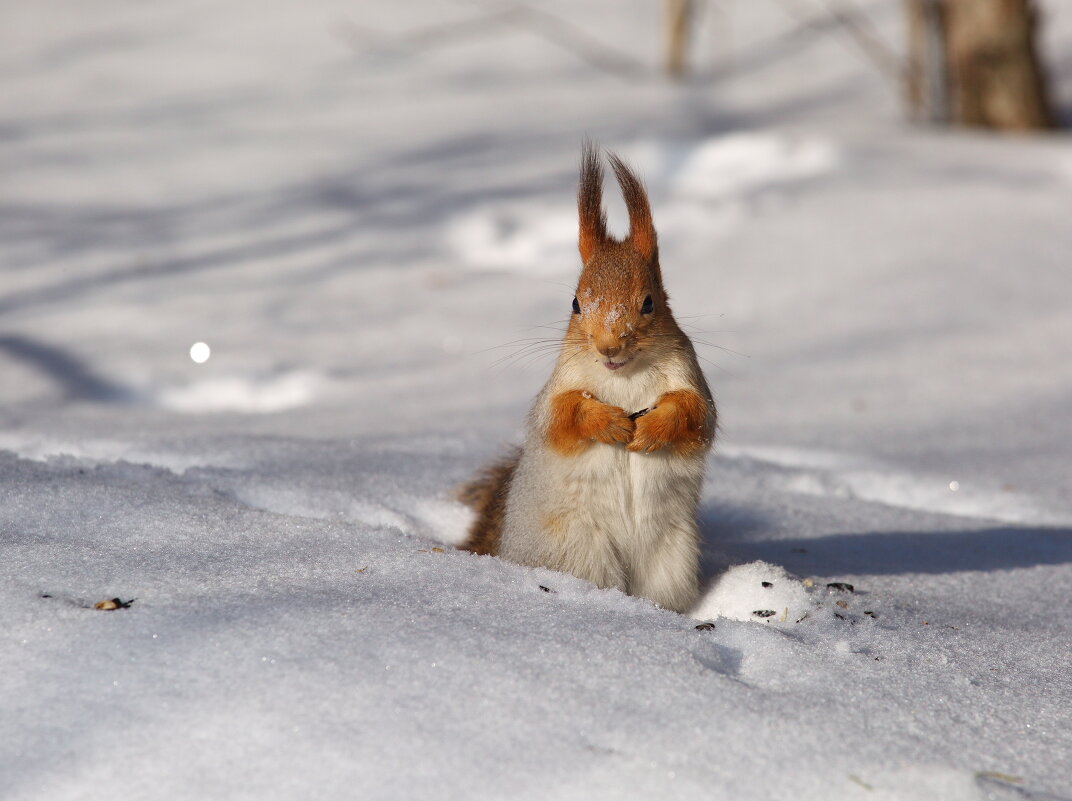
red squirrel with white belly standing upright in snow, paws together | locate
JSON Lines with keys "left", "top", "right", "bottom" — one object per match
{"left": 461, "top": 142, "right": 717, "bottom": 612}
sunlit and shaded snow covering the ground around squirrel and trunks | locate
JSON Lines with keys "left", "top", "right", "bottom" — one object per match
{"left": 0, "top": 0, "right": 1072, "bottom": 801}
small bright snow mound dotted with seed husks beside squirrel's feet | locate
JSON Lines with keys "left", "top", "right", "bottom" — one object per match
{"left": 691, "top": 562, "right": 813, "bottom": 623}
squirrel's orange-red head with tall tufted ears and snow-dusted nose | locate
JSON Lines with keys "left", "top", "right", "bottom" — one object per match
{"left": 567, "top": 142, "right": 672, "bottom": 372}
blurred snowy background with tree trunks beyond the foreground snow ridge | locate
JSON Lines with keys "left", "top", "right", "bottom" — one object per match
{"left": 0, "top": 0, "right": 1072, "bottom": 521}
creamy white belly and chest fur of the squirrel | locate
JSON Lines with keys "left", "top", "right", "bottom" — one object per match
{"left": 500, "top": 358, "right": 704, "bottom": 611}
